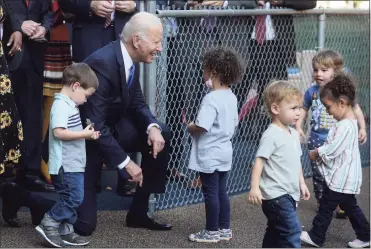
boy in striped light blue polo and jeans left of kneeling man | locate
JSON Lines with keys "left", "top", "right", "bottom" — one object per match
{"left": 36, "top": 63, "right": 100, "bottom": 247}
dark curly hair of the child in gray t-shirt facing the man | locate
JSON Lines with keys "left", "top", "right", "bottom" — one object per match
{"left": 203, "top": 47, "right": 245, "bottom": 85}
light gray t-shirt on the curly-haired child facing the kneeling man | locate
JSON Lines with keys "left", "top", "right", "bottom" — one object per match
{"left": 188, "top": 89, "right": 238, "bottom": 173}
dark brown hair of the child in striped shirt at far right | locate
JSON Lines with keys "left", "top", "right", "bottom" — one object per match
{"left": 320, "top": 72, "right": 356, "bottom": 106}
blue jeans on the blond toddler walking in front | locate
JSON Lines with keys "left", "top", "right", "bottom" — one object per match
{"left": 262, "top": 194, "right": 301, "bottom": 248}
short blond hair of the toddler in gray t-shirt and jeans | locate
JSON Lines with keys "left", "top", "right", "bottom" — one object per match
{"left": 263, "top": 80, "right": 303, "bottom": 117}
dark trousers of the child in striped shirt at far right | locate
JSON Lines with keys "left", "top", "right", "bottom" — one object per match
{"left": 309, "top": 186, "right": 370, "bottom": 247}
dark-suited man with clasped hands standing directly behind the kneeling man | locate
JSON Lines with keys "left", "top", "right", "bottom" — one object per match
{"left": 59, "top": 0, "right": 140, "bottom": 62}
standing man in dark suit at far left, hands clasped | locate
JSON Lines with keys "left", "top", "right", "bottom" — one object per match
{"left": 3, "top": 0, "right": 53, "bottom": 182}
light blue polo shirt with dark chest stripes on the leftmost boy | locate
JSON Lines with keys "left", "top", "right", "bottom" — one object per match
{"left": 48, "top": 93, "right": 86, "bottom": 175}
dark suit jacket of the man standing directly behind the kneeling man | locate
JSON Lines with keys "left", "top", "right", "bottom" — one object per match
{"left": 59, "top": 0, "right": 140, "bottom": 62}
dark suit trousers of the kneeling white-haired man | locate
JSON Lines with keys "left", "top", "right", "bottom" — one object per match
{"left": 74, "top": 120, "right": 171, "bottom": 236}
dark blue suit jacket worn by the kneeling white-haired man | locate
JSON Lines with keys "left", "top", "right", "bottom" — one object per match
{"left": 81, "top": 40, "right": 158, "bottom": 167}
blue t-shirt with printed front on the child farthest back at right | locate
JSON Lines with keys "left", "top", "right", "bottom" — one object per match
{"left": 304, "top": 85, "right": 336, "bottom": 141}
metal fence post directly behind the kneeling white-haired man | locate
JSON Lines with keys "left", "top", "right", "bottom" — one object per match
{"left": 144, "top": 1, "right": 157, "bottom": 217}
